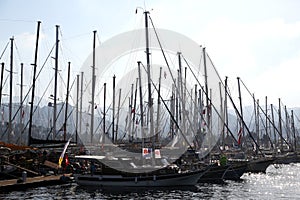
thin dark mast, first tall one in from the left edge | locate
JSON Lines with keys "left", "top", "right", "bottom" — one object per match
{"left": 7, "top": 37, "right": 14, "bottom": 143}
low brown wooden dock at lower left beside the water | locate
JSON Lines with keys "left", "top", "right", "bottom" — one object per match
{"left": 0, "top": 174, "right": 70, "bottom": 193}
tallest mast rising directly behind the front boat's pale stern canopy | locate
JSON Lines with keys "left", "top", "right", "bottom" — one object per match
{"left": 91, "top": 31, "right": 96, "bottom": 143}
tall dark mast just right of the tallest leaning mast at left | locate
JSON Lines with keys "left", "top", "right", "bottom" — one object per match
{"left": 52, "top": 25, "right": 59, "bottom": 139}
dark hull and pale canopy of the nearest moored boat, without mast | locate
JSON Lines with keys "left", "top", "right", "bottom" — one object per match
{"left": 74, "top": 156, "right": 209, "bottom": 188}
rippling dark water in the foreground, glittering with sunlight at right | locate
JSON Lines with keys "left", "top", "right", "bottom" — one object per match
{"left": 0, "top": 163, "right": 300, "bottom": 200}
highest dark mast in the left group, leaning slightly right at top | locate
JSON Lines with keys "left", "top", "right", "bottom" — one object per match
{"left": 28, "top": 21, "right": 41, "bottom": 145}
